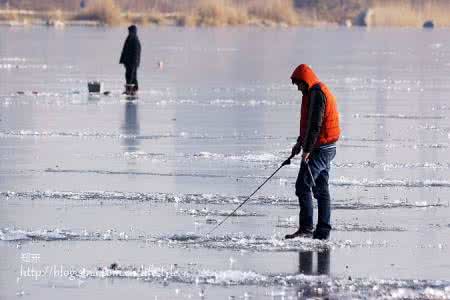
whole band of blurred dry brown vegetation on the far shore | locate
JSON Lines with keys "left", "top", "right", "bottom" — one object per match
{"left": 0, "top": 0, "right": 450, "bottom": 27}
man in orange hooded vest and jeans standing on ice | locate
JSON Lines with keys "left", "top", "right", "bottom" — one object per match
{"left": 285, "top": 64, "right": 341, "bottom": 240}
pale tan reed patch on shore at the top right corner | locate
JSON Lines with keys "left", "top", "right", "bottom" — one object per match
{"left": 371, "top": 0, "right": 450, "bottom": 27}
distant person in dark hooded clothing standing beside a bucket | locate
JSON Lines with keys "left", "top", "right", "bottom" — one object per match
{"left": 120, "top": 25, "right": 141, "bottom": 95}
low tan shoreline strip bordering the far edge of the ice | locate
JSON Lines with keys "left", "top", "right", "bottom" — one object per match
{"left": 0, "top": 9, "right": 442, "bottom": 28}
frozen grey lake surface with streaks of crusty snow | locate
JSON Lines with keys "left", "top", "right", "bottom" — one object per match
{"left": 0, "top": 27, "right": 450, "bottom": 299}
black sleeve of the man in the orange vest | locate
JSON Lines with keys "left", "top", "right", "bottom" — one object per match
{"left": 303, "top": 89, "right": 326, "bottom": 153}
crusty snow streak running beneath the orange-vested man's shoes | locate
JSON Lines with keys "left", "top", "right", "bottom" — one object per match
{"left": 0, "top": 228, "right": 396, "bottom": 252}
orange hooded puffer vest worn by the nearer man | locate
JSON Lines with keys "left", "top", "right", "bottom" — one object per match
{"left": 291, "top": 64, "right": 341, "bottom": 146}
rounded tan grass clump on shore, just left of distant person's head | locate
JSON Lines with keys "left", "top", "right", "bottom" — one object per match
{"left": 73, "top": 0, "right": 122, "bottom": 25}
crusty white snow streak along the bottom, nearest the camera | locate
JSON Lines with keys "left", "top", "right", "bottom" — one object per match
{"left": 74, "top": 265, "right": 450, "bottom": 299}
